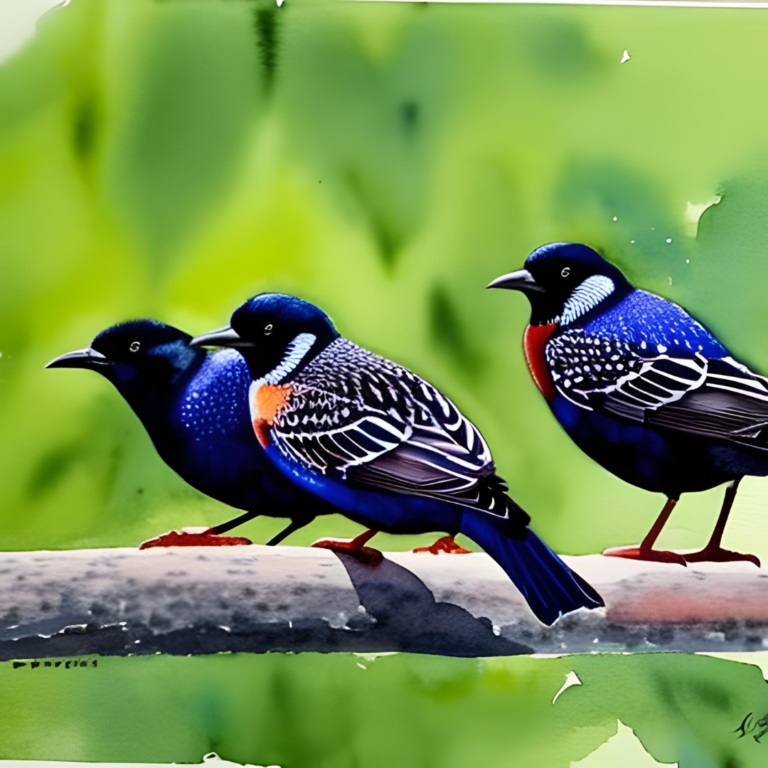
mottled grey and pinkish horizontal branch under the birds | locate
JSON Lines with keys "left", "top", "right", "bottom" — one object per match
{"left": 0, "top": 546, "right": 768, "bottom": 660}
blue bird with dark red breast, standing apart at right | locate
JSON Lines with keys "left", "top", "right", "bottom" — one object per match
{"left": 488, "top": 243, "right": 768, "bottom": 566}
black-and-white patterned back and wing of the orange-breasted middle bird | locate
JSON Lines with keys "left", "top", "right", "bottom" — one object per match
{"left": 273, "top": 339, "right": 524, "bottom": 518}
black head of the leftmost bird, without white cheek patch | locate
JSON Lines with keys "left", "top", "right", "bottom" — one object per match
{"left": 46, "top": 320, "right": 205, "bottom": 405}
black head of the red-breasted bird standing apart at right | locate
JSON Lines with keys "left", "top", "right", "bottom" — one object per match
{"left": 488, "top": 243, "right": 633, "bottom": 325}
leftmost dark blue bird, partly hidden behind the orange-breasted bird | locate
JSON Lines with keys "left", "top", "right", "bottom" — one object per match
{"left": 46, "top": 320, "right": 336, "bottom": 548}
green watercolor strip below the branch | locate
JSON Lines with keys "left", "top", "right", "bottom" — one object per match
{"left": 0, "top": 654, "right": 768, "bottom": 768}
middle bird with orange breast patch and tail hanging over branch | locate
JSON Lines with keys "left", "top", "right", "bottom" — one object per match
{"left": 192, "top": 294, "right": 603, "bottom": 624}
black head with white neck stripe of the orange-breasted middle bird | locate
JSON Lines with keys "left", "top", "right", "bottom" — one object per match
{"left": 192, "top": 293, "right": 339, "bottom": 384}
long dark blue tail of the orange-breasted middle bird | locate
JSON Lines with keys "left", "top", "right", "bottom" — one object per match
{"left": 461, "top": 509, "right": 605, "bottom": 624}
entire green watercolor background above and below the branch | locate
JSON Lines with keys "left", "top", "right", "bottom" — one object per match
{"left": 0, "top": 0, "right": 768, "bottom": 768}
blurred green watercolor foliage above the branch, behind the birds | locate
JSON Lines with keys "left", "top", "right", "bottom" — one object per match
{"left": 7, "top": 0, "right": 768, "bottom": 554}
